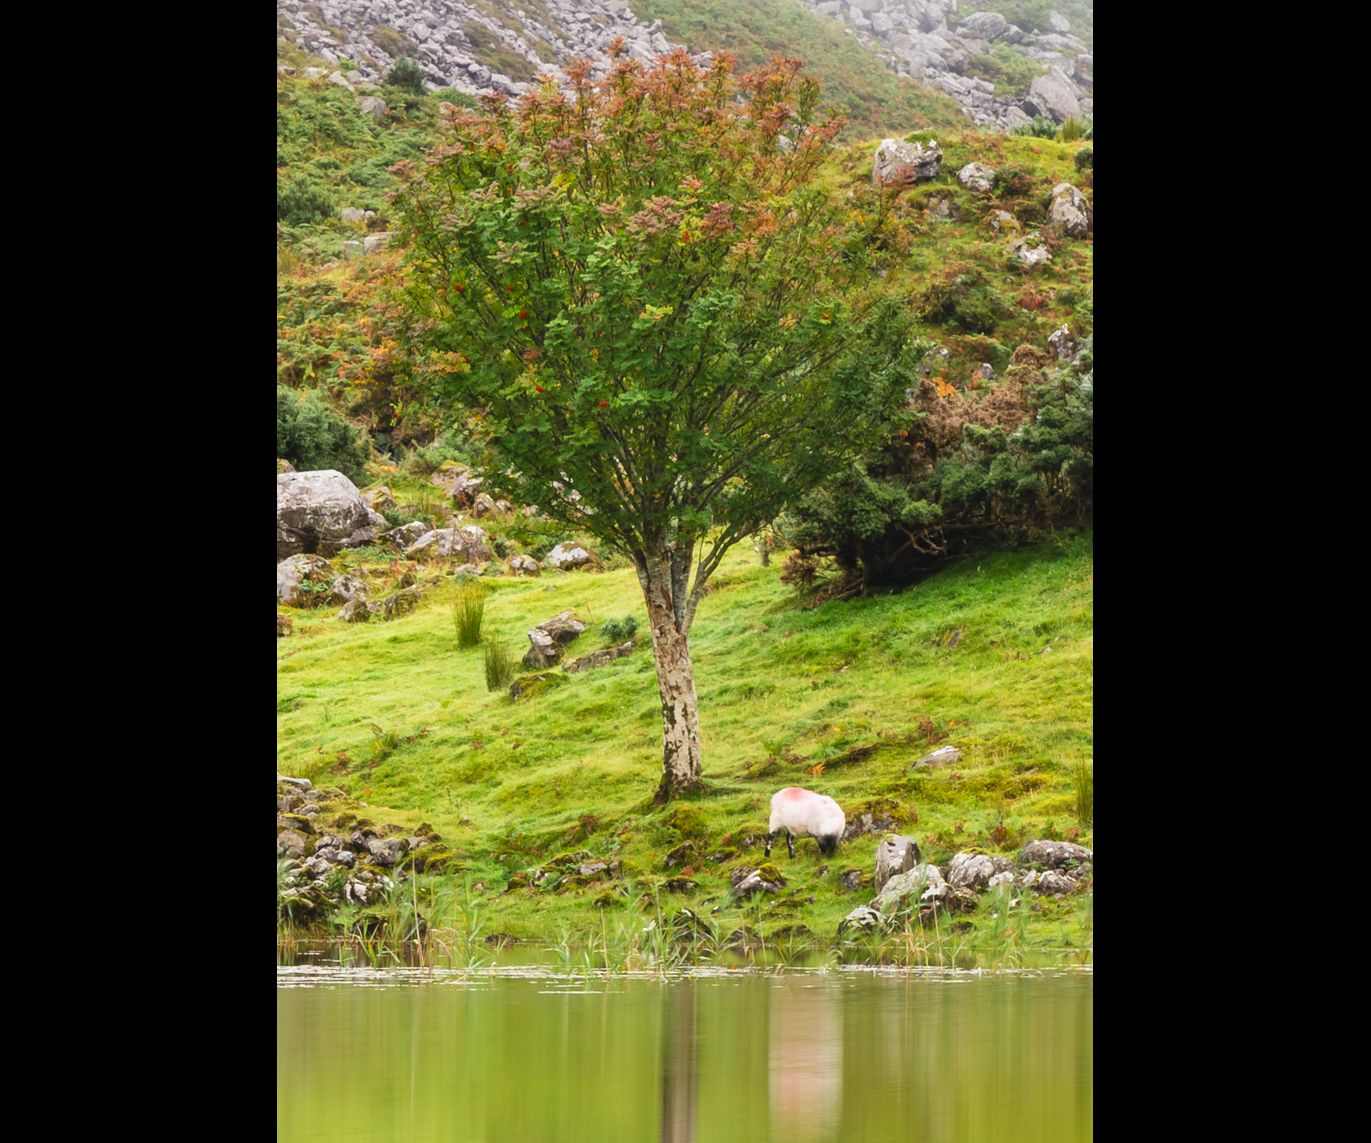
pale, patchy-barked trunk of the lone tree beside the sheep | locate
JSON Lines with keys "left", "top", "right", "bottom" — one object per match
{"left": 638, "top": 559, "right": 699, "bottom": 806}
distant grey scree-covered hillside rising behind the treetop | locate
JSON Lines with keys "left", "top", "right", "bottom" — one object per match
{"left": 277, "top": 0, "right": 1093, "bottom": 127}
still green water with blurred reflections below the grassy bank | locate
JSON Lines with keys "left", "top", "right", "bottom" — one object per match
{"left": 277, "top": 968, "right": 1094, "bottom": 1143}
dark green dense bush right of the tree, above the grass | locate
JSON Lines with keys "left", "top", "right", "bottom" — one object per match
{"left": 781, "top": 340, "right": 1094, "bottom": 595}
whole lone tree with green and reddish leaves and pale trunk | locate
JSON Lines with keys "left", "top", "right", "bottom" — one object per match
{"left": 393, "top": 45, "right": 910, "bottom": 800}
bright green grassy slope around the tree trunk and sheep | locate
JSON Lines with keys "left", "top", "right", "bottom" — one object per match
{"left": 277, "top": 537, "right": 1093, "bottom": 947}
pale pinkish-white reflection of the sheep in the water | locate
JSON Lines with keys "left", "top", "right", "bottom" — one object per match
{"left": 771, "top": 976, "right": 843, "bottom": 1143}
